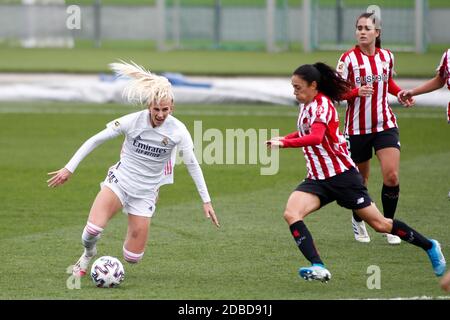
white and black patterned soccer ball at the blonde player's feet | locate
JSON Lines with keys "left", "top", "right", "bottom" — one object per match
{"left": 91, "top": 256, "right": 125, "bottom": 288}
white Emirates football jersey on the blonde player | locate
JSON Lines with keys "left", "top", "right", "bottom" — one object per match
{"left": 107, "top": 110, "right": 194, "bottom": 197}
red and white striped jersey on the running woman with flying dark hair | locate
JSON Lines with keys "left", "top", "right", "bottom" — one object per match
{"left": 297, "top": 93, "right": 355, "bottom": 180}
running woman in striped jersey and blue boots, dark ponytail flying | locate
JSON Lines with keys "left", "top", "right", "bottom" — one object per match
{"left": 266, "top": 63, "right": 446, "bottom": 281}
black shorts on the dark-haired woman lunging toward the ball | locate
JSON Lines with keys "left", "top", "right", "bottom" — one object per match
{"left": 295, "top": 168, "right": 372, "bottom": 209}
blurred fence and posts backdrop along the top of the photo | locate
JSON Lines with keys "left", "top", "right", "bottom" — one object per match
{"left": 0, "top": 0, "right": 450, "bottom": 52}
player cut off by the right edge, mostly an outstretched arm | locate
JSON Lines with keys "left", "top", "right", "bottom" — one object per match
{"left": 399, "top": 49, "right": 450, "bottom": 123}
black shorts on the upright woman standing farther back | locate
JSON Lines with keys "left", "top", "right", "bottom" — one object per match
{"left": 347, "top": 128, "right": 400, "bottom": 163}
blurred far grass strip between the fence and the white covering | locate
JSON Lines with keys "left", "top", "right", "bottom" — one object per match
{"left": 0, "top": 47, "right": 446, "bottom": 78}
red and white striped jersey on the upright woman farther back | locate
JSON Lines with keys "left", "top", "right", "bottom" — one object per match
{"left": 337, "top": 46, "right": 397, "bottom": 135}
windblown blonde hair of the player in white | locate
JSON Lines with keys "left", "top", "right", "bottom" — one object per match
{"left": 109, "top": 60, "right": 174, "bottom": 106}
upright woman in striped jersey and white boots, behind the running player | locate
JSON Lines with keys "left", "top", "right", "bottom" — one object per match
{"left": 337, "top": 13, "right": 413, "bottom": 244}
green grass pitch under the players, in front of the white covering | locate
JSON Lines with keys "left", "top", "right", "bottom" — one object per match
{"left": 0, "top": 103, "right": 450, "bottom": 300}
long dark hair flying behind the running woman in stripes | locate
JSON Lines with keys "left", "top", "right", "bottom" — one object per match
{"left": 293, "top": 62, "right": 353, "bottom": 101}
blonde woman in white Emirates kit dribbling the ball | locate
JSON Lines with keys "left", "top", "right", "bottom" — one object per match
{"left": 47, "top": 62, "right": 219, "bottom": 276}
